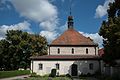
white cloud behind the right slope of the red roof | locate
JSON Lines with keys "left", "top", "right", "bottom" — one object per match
{"left": 79, "top": 31, "right": 103, "bottom": 47}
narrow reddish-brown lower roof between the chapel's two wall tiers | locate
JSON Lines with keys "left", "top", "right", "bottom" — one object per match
{"left": 31, "top": 55, "right": 100, "bottom": 60}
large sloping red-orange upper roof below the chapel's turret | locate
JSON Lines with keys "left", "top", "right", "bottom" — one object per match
{"left": 51, "top": 29, "right": 96, "bottom": 45}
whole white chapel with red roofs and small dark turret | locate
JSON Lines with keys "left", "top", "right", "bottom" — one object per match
{"left": 31, "top": 16, "right": 101, "bottom": 76}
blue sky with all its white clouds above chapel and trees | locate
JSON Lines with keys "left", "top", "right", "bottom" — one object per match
{"left": 0, "top": 0, "right": 113, "bottom": 47}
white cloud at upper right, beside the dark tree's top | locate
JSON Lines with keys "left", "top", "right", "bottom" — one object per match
{"left": 95, "top": 0, "right": 114, "bottom": 18}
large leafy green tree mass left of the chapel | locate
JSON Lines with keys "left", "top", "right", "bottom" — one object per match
{"left": 0, "top": 30, "right": 47, "bottom": 70}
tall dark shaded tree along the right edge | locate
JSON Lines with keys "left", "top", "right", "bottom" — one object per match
{"left": 99, "top": 0, "right": 120, "bottom": 65}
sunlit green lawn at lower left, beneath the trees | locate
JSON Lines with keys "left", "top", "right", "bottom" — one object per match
{"left": 0, "top": 70, "right": 30, "bottom": 78}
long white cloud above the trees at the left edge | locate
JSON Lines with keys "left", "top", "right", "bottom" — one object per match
{"left": 0, "top": 21, "right": 32, "bottom": 39}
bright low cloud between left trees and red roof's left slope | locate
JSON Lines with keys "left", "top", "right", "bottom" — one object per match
{"left": 40, "top": 31, "right": 59, "bottom": 43}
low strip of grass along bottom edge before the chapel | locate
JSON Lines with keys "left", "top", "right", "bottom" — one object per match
{"left": 17, "top": 77, "right": 72, "bottom": 80}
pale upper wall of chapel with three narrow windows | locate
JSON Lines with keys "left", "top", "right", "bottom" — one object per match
{"left": 48, "top": 47, "right": 98, "bottom": 55}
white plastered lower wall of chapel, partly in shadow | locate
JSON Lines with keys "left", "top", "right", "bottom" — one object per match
{"left": 32, "top": 60, "right": 99, "bottom": 75}
